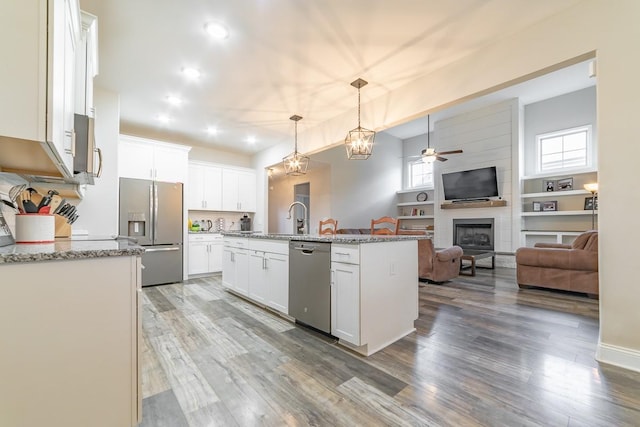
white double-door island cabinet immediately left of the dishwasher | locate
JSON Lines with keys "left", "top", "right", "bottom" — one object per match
{"left": 248, "top": 239, "right": 289, "bottom": 314}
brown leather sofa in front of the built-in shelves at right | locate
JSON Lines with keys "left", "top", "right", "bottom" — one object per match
{"left": 516, "top": 230, "right": 599, "bottom": 296}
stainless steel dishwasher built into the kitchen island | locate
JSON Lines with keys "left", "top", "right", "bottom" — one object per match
{"left": 289, "top": 240, "right": 331, "bottom": 333}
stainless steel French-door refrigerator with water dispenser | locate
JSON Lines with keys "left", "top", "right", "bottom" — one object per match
{"left": 119, "top": 178, "right": 183, "bottom": 286}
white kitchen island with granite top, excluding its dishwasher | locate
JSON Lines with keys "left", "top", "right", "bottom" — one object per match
{"left": 222, "top": 233, "right": 426, "bottom": 356}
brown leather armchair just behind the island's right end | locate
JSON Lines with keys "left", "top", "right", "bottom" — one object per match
{"left": 418, "top": 239, "right": 462, "bottom": 283}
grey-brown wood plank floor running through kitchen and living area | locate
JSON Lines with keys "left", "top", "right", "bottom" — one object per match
{"left": 141, "top": 268, "right": 640, "bottom": 427}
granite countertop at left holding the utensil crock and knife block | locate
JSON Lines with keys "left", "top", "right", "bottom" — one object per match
{"left": 0, "top": 237, "right": 144, "bottom": 264}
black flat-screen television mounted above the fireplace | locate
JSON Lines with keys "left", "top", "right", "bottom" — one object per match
{"left": 442, "top": 166, "right": 498, "bottom": 200}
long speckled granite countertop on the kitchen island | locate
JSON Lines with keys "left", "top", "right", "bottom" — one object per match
{"left": 223, "top": 231, "right": 430, "bottom": 244}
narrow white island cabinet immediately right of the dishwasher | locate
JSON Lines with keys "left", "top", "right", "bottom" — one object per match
{"left": 331, "top": 245, "right": 360, "bottom": 346}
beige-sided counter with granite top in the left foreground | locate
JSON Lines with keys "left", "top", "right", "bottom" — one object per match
{"left": 0, "top": 238, "right": 144, "bottom": 426}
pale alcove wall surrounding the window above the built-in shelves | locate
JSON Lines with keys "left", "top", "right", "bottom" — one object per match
{"left": 523, "top": 86, "right": 598, "bottom": 175}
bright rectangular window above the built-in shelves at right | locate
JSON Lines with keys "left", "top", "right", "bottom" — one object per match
{"left": 536, "top": 126, "right": 591, "bottom": 172}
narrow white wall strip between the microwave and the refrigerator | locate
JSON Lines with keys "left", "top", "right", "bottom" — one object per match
{"left": 72, "top": 87, "right": 120, "bottom": 236}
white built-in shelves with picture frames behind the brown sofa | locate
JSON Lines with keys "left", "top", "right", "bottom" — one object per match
{"left": 520, "top": 170, "right": 598, "bottom": 246}
